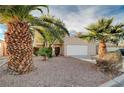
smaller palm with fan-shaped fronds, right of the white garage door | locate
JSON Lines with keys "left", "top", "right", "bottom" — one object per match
{"left": 80, "top": 18, "right": 124, "bottom": 58}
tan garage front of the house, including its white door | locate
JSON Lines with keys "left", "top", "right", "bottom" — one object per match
{"left": 64, "top": 37, "right": 96, "bottom": 56}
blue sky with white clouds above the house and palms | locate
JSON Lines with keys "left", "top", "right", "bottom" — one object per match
{"left": 0, "top": 5, "right": 124, "bottom": 39}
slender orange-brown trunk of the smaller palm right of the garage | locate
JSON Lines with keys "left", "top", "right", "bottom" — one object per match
{"left": 98, "top": 40, "right": 107, "bottom": 59}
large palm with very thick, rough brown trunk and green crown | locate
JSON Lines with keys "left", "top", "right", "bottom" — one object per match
{"left": 0, "top": 5, "right": 48, "bottom": 74}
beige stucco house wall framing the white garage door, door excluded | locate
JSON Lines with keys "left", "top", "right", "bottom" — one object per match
{"left": 34, "top": 37, "right": 96, "bottom": 56}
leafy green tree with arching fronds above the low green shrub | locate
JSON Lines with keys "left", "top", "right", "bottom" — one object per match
{"left": 33, "top": 15, "right": 69, "bottom": 47}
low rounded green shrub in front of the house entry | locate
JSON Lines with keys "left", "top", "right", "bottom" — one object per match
{"left": 37, "top": 48, "right": 52, "bottom": 58}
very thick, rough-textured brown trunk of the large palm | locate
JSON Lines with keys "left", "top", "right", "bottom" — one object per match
{"left": 5, "top": 22, "right": 33, "bottom": 74}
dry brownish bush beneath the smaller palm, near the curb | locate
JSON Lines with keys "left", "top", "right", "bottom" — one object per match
{"left": 96, "top": 51, "right": 122, "bottom": 75}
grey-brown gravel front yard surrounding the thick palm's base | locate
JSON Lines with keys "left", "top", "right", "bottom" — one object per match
{"left": 0, "top": 57, "right": 109, "bottom": 87}
